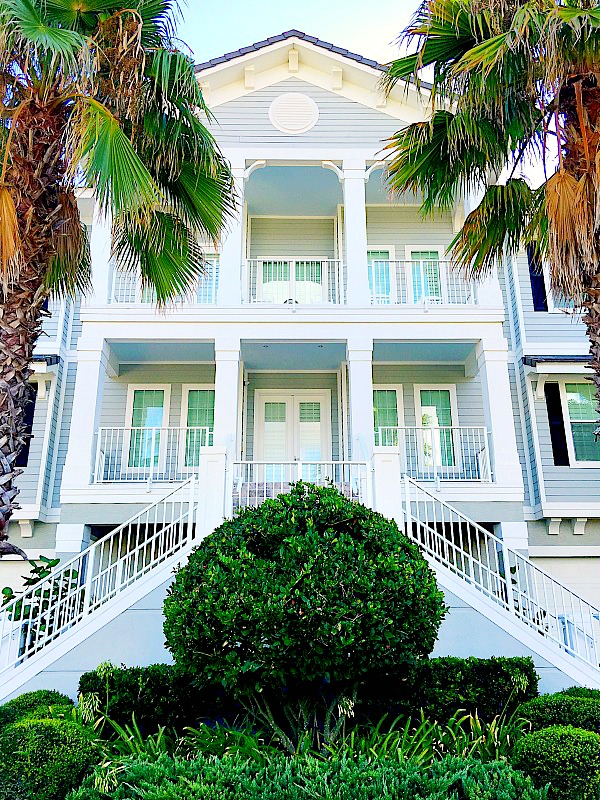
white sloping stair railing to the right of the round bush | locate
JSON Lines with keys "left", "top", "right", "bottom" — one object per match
{"left": 403, "top": 476, "right": 600, "bottom": 668}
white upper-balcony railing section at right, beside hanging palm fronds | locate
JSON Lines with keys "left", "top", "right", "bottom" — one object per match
{"left": 368, "top": 259, "right": 477, "bottom": 305}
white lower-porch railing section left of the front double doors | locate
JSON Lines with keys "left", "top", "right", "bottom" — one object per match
{"left": 94, "top": 427, "right": 213, "bottom": 484}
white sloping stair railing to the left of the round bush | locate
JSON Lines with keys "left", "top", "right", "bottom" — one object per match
{"left": 0, "top": 476, "right": 197, "bottom": 675}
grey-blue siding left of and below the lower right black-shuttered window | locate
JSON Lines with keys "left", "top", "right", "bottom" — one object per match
{"left": 534, "top": 386, "right": 600, "bottom": 503}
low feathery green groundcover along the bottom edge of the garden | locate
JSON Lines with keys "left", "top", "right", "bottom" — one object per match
{"left": 69, "top": 758, "right": 546, "bottom": 800}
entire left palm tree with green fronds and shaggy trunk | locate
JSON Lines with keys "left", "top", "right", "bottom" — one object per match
{"left": 0, "top": 0, "right": 235, "bottom": 557}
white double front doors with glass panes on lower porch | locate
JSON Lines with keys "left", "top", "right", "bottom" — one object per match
{"left": 254, "top": 390, "right": 331, "bottom": 481}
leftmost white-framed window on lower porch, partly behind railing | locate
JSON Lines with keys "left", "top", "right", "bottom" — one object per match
{"left": 127, "top": 387, "right": 168, "bottom": 469}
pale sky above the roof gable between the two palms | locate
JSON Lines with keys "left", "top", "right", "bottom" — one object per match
{"left": 179, "top": 0, "right": 417, "bottom": 62}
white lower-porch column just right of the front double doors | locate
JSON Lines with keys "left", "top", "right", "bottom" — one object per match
{"left": 346, "top": 339, "right": 375, "bottom": 461}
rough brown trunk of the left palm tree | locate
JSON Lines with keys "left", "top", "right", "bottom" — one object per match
{"left": 0, "top": 97, "right": 66, "bottom": 558}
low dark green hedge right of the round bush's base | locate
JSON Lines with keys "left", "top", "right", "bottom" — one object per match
{"left": 356, "top": 656, "right": 539, "bottom": 722}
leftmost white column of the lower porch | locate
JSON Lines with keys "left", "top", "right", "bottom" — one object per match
{"left": 62, "top": 341, "right": 113, "bottom": 489}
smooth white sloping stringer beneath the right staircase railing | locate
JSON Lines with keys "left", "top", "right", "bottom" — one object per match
{"left": 423, "top": 553, "right": 600, "bottom": 689}
